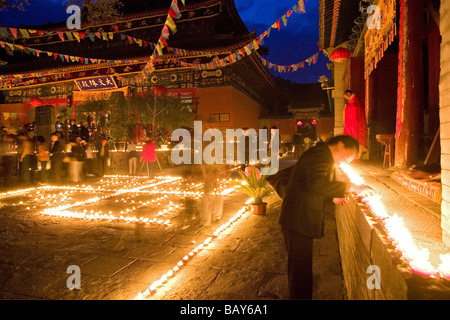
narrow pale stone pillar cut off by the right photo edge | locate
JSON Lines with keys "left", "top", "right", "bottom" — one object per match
{"left": 439, "top": 1, "right": 450, "bottom": 246}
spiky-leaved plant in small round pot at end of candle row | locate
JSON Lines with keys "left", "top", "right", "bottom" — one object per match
{"left": 238, "top": 166, "right": 272, "bottom": 215}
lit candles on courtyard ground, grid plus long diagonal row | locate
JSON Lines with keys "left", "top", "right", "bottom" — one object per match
{"left": 0, "top": 169, "right": 260, "bottom": 300}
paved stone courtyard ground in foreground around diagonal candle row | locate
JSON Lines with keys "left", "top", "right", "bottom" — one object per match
{"left": 0, "top": 161, "right": 345, "bottom": 300}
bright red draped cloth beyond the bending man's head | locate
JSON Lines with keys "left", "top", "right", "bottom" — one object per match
{"left": 344, "top": 95, "right": 367, "bottom": 148}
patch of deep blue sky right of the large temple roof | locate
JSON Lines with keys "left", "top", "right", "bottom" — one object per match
{"left": 235, "top": 0, "right": 330, "bottom": 83}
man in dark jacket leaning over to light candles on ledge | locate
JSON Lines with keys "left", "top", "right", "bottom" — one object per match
{"left": 279, "top": 136, "right": 373, "bottom": 299}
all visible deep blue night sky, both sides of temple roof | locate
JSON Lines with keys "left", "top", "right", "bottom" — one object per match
{"left": 0, "top": 0, "right": 330, "bottom": 83}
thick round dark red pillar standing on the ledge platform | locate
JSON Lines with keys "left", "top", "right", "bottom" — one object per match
{"left": 395, "top": 0, "right": 424, "bottom": 167}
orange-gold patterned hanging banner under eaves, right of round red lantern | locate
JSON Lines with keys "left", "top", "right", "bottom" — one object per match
{"left": 364, "top": 0, "right": 397, "bottom": 79}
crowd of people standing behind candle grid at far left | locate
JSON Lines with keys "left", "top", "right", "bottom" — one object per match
{"left": 0, "top": 117, "right": 114, "bottom": 187}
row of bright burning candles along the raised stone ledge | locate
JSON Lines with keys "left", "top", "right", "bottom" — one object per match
{"left": 340, "top": 164, "right": 450, "bottom": 279}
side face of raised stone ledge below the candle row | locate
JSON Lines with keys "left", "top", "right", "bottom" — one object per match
{"left": 336, "top": 171, "right": 450, "bottom": 300}
